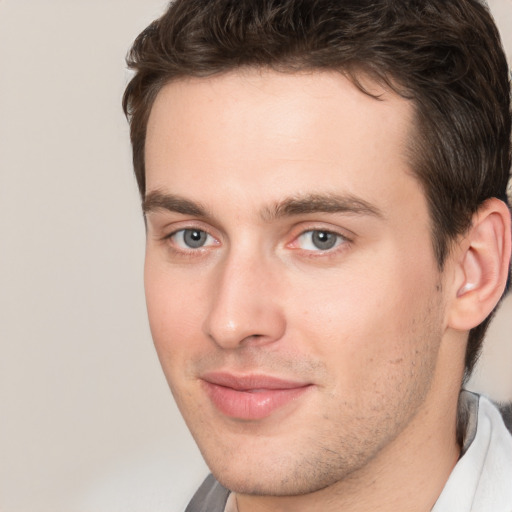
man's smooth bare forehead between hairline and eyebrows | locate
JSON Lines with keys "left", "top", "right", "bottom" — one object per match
{"left": 146, "top": 69, "right": 417, "bottom": 216}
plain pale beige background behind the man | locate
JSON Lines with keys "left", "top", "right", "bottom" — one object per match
{"left": 0, "top": 0, "right": 512, "bottom": 512}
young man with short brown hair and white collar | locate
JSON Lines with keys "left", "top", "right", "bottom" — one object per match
{"left": 124, "top": 0, "right": 512, "bottom": 512}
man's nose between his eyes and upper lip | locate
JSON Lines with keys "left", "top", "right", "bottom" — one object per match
{"left": 204, "top": 250, "right": 286, "bottom": 349}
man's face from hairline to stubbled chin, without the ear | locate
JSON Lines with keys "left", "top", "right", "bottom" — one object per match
{"left": 145, "top": 70, "right": 444, "bottom": 495}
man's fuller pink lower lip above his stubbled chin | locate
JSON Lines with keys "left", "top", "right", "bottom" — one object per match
{"left": 203, "top": 381, "right": 311, "bottom": 420}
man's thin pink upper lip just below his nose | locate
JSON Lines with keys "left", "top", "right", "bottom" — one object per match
{"left": 201, "top": 372, "right": 310, "bottom": 391}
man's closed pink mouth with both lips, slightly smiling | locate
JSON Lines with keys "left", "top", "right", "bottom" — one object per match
{"left": 202, "top": 372, "right": 312, "bottom": 420}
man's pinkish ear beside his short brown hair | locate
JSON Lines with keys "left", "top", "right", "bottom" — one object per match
{"left": 448, "top": 198, "right": 511, "bottom": 331}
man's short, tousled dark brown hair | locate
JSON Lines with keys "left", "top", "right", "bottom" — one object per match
{"left": 123, "top": 0, "right": 511, "bottom": 376}
